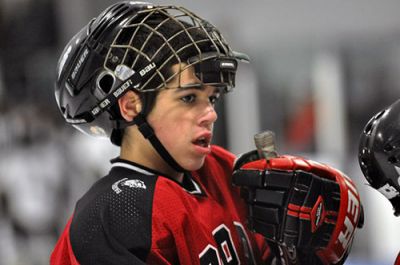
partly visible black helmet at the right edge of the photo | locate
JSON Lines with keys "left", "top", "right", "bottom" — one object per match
{"left": 358, "top": 100, "right": 400, "bottom": 216}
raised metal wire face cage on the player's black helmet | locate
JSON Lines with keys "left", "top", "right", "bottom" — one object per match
{"left": 104, "top": 6, "right": 244, "bottom": 92}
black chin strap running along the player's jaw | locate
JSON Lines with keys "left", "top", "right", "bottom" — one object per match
{"left": 133, "top": 113, "right": 186, "bottom": 172}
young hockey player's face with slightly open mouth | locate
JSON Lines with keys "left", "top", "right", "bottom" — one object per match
{"left": 148, "top": 65, "right": 220, "bottom": 170}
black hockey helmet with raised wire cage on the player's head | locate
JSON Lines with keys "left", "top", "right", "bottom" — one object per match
{"left": 55, "top": 1, "right": 248, "bottom": 142}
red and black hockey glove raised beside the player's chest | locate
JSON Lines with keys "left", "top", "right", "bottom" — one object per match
{"left": 233, "top": 151, "right": 363, "bottom": 264}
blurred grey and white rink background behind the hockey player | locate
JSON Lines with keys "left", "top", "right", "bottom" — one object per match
{"left": 0, "top": 0, "right": 400, "bottom": 265}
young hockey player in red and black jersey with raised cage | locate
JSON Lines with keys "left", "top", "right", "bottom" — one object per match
{"left": 50, "top": 1, "right": 360, "bottom": 265}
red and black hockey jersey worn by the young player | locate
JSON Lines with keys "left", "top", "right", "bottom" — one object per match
{"left": 50, "top": 146, "right": 270, "bottom": 265}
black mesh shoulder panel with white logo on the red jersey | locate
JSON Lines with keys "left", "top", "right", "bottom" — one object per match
{"left": 70, "top": 167, "right": 157, "bottom": 265}
